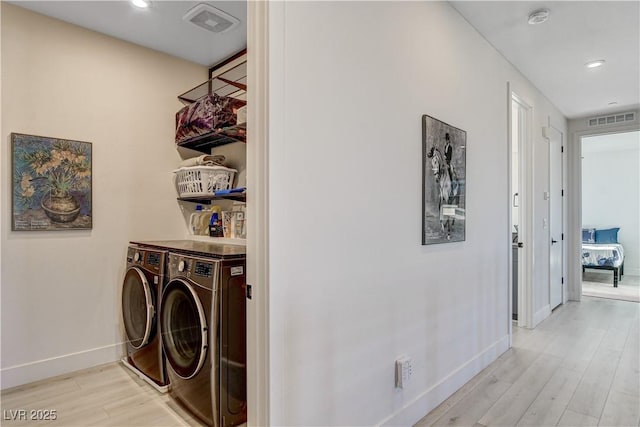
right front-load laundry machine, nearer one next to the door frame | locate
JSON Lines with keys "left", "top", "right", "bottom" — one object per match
{"left": 160, "top": 248, "right": 247, "bottom": 427}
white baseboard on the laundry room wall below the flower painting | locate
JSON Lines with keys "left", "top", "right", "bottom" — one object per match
{"left": 0, "top": 343, "right": 122, "bottom": 390}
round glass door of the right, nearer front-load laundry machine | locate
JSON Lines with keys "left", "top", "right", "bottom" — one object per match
{"left": 160, "top": 279, "right": 207, "bottom": 380}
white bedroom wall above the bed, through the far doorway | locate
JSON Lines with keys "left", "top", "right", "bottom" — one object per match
{"left": 582, "top": 132, "right": 640, "bottom": 275}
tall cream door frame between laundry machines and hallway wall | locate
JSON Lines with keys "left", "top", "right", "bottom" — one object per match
{"left": 247, "top": 1, "right": 270, "bottom": 426}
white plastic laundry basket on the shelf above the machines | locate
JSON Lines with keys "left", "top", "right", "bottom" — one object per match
{"left": 173, "top": 166, "right": 237, "bottom": 197}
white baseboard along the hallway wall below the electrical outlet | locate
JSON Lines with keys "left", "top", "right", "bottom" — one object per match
{"left": 378, "top": 335, "right": 509, "bottom": 426}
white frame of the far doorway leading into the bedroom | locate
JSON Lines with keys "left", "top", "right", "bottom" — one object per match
{"left": 565, "top": 122, "right": 640, "bottom": 301}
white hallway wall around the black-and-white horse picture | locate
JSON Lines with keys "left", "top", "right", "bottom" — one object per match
{"left": 268, "top": 2, "right": 566, "bottom": 426}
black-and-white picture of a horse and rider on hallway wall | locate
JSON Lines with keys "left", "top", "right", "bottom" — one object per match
{"left": 422, "top": 115, "right": 466, "bottom": 245}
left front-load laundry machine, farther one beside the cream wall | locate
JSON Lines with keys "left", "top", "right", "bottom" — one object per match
{"left": 122, "top": 244, "right": 167, "bottom": 392}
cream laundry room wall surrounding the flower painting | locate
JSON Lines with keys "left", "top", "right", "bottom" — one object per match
{"left": 1, "top": 2, "right": 207, "bottom": 388}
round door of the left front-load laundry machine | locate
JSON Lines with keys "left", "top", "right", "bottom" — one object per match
{"left": 122, "top": 267, "right": 156, "bottom": 349}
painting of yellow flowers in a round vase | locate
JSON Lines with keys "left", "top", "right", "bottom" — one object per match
{"left": 11, "top": 133, "right": 93, "bottom": 231}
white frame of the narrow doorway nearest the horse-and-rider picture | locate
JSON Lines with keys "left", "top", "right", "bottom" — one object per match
{"left": 507, "top": 87, "right": 534, "bottom": 332}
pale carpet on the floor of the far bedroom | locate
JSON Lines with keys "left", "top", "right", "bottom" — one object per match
{"left": 582, "top": 270, "right": 640, "bottom": 302}
